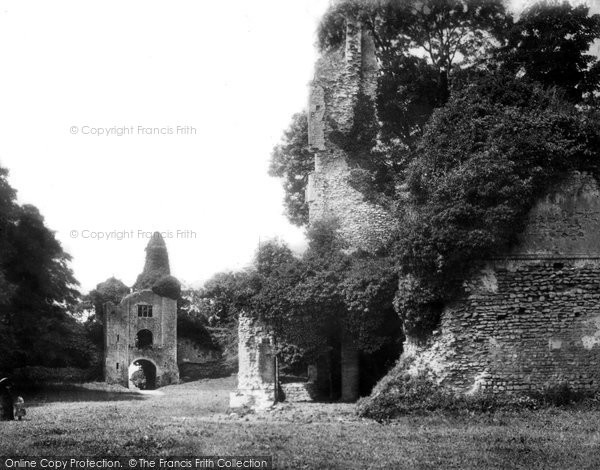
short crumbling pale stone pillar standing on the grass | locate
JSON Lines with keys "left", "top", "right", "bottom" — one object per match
{"left": 229, "top": 313, "right": 276, "bottom": 410}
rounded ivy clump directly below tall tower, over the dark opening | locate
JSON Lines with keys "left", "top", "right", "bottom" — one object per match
{"left": 254, "top": 221, "right": 399, "bottom": 357}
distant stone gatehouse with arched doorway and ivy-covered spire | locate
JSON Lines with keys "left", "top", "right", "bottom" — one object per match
{"left": 104, "top": 232, "right": 179, "bottom": 389}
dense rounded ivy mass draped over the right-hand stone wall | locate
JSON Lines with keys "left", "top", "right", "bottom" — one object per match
{"left": 397, "top": 74, "right": 600, "bottom": 335}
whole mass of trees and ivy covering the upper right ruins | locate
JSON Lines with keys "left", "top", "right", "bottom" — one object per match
{"left": 270, "top": 0, "right": 600, "bottom": 339}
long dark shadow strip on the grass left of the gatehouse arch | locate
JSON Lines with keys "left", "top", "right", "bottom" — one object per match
{"left": 22, "top": 384, "right": 149, "bottom": 407}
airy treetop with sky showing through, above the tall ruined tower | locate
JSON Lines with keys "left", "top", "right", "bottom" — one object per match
{"left": 318, "top": 0, "right": 512, "bottom": 106}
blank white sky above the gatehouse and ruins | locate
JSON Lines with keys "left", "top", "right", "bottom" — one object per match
{"left": 0, "top": 0, "right": 592, "bottom": 291}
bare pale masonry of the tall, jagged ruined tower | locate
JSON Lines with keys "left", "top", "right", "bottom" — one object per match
{"left": 306, "top": 19, "right": 392, "bottom": 250}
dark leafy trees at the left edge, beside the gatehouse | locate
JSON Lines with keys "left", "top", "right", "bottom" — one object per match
{"left": 0, "top": 168, "right": 97, "bottom": 375}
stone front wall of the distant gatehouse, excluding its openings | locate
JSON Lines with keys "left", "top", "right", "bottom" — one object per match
{"left": 104, "top": 289, "right": 179, "bottom": 386}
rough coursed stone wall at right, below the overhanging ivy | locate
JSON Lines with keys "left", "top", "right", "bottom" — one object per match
{"left": 404, "top": 173, "right": 600, "bottom": 393}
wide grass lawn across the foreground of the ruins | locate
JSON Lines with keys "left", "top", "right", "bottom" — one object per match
{"left": 0, "top": 377, "right": 600, "bottom": 469}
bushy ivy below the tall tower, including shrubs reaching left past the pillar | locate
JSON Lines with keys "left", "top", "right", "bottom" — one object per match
{"left": 202, "top": 221, "right": 402, "bottom": 392}
